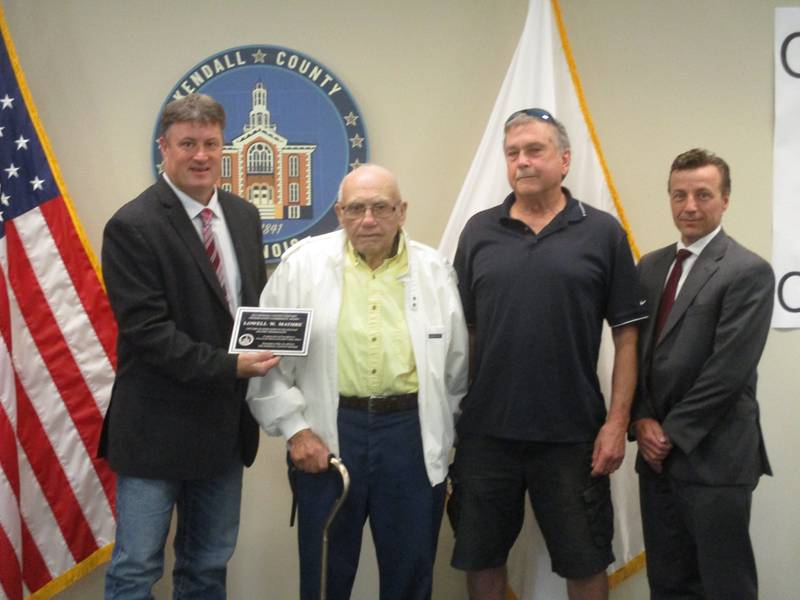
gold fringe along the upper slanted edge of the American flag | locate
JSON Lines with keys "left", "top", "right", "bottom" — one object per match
{"left": 0, "top": 6, "right": 106, "bottom": 290}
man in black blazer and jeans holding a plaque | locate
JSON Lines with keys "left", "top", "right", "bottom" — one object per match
{"left": 100, "top": 94, "right": 278, "bottom": 599}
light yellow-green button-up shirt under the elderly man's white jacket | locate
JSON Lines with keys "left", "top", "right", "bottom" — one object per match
{"left": 336, "top": 235, "right": 419, "bottom": 396}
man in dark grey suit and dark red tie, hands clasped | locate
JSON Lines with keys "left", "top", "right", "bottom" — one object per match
{"left": 632, "top": 149, "right": 774, "bottom": 600}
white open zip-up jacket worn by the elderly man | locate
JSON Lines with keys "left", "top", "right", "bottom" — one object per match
{"left": 247, "top": 230, "right": 468, "bottom": 485}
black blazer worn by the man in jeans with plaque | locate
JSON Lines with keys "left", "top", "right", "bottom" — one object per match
{"left": 99, "top": 178, "right": 266, "bottom": 479}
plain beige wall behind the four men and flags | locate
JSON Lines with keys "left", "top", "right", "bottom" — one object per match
{"left": 2, "top": 0, "right": 800, "bottom": 600}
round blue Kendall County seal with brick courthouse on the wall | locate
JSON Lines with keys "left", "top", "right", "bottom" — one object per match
{"left": 152, "top": 45, "right": 368, "bottom": 263}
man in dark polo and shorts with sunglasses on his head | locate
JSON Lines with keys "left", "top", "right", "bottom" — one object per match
{"left": 452, "top": 109, "right": 646, "bottom": 600}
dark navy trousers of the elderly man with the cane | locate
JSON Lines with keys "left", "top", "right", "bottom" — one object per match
{"left": 297, "top": 408, "right": 445, "bottom": 600}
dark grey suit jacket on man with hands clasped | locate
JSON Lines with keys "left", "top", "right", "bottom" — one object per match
{"left": 633, "top": 231, "right": 775, "bottom": 485}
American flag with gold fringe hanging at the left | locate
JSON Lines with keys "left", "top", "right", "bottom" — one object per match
{"left": 0, "top": 12, "right": 116, "bottom": 600}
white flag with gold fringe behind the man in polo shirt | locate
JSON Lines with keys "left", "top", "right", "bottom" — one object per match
{"left": 439, "top": 0, "right": 644, "bottom": 600}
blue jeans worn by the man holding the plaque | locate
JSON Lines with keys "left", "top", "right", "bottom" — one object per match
{"left": 105, "top": 462, "right": 243, "bottom": 600}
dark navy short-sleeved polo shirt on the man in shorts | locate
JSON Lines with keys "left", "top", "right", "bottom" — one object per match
{"left": 454, "top": 188, "right": 647, "bottom": 442}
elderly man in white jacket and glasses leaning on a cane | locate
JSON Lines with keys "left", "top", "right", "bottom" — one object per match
{"left": 249, "top": 165, "right": 468, "bottom": 600}
